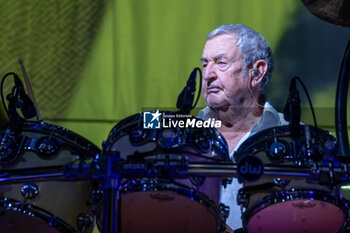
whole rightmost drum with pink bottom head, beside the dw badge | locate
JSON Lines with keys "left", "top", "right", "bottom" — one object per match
{"left": 235, "top": 125, "right": 348, "bottom": 233}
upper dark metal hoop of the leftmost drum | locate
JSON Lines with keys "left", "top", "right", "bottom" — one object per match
{"left": 23, "top": 121, "right": 101, "bottom": 156}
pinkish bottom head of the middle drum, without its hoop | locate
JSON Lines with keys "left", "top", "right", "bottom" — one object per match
{"left": 122, "top": 191, "right": 217, "bottom": 233}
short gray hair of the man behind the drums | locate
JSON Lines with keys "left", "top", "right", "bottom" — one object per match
{"left": 206, "top": 24, "right": 274, "bottom": 92}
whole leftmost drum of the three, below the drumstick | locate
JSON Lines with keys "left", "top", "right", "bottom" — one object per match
{"left": 0, "top": 122, "right": 100, "bottom": 233}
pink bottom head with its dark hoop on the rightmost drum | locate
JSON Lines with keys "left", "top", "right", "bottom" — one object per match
{"left": 247, "top": 190, "right": 346, "bottom": 233}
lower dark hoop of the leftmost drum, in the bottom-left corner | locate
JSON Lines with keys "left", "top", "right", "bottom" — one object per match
{"left": 0, "top": 197, "right": 76, "bottom": 233}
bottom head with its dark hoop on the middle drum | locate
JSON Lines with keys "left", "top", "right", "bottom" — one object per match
{"left": 98, "top": 179, "right": 223, "bottom": 233}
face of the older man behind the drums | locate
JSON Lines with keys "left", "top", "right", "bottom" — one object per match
{"left": 201, "top": 34, "right": 249, "bottom": 108}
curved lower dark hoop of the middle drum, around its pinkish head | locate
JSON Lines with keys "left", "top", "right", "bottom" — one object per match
{"left": 97, "top": 178, "right": 225, "bottom": 233}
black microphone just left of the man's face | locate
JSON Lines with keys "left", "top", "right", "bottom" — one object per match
{"left": 176, "top": 67, "right": 200, "bottom": 114}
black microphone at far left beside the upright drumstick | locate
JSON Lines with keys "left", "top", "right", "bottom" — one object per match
{"left": 14, "top": 75, "right": 36, "bottom": 119}
